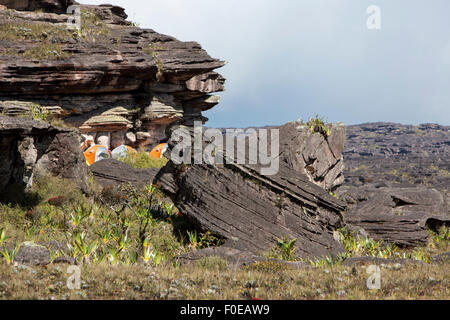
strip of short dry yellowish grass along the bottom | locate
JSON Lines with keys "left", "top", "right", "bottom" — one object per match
{"left": 0, "top": 258, "right": 450, "bottom": 300}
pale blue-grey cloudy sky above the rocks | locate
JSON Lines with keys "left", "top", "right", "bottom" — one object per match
{"left": 79, "top": 0, "right": 450, "bottom": 127}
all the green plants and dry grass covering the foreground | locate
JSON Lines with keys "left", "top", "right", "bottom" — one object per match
{"left": 0, "top": 172, "right": 450, "bottom": 299}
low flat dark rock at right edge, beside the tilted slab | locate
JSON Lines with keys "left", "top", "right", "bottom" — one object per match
{"left": 338, "top": 187, "right": 450, "bottom": 247}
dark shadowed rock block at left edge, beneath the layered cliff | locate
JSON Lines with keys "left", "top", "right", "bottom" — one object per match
{"left": 0, "top": 116, "right": 87, "bottom": 189}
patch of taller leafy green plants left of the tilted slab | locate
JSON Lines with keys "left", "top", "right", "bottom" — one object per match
{"left": 0, "top": 176, "right": 209, "bottom": 264}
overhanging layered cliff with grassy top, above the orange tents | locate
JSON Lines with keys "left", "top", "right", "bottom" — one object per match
{"left": 0, "top": 0, "right": 225, "bottom": 149}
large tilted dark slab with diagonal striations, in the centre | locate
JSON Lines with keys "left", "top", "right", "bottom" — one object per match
{"left": 155, "top": 159, "right": 345, "bottom": 257}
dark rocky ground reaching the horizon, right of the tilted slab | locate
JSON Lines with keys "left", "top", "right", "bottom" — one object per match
{"left": 342, "top": 123, "right": 450, "bottom": 246}
